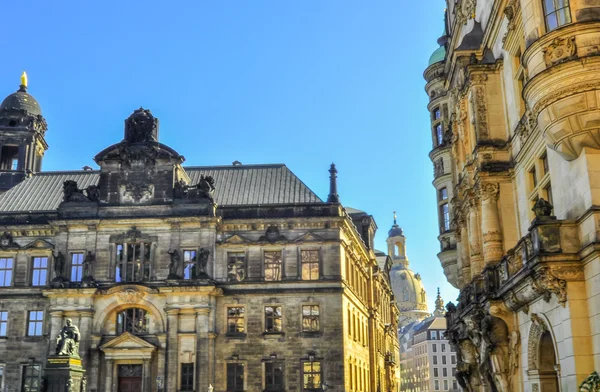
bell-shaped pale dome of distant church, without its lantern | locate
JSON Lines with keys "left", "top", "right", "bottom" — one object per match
{"left": 390, "top": 264, "right": 428, "bottom": 315}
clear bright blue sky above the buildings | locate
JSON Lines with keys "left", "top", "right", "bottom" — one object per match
{"left": 0, "top": 0, "right": 457, "bottom": 311}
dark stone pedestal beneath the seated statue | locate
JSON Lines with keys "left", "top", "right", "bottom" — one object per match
{"left": 44, "top": 355, "right": 85, "bottom": 392}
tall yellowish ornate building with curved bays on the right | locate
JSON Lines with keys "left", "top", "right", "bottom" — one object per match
{"left": 424, "top": 0, "right": 600, "bottom": 392}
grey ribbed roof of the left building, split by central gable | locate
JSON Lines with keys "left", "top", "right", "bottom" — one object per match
{"left": 0, "top": 164, "right": 322, "bottom": 213}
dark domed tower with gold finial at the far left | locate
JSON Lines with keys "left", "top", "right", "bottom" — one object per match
{"left": 0, "top": 72, "right": 48, "bottom": 192}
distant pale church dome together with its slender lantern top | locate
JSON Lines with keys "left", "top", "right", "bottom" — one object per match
{"left": 387, "top": 212, "right": 429, "bottom": 327}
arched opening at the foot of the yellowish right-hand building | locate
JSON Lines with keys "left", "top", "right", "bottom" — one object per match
{"left": 527, "top": 313, "right": 560, "bottom": 392}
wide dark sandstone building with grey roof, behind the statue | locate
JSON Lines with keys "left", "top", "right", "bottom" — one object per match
{"left": 0, "top": 76, "right": 399, "bottom": 392}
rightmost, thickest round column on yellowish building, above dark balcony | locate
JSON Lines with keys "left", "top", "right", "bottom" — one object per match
{"left": 480, "top": 183, "right": 504, "bottom": 266}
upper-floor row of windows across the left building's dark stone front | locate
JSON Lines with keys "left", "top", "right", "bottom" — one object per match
{"left": 0, "top": 250, "right": 320, "bottom": 287}
